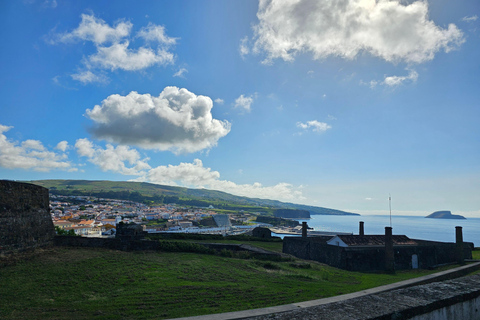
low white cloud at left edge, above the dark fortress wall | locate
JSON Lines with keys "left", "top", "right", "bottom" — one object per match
{"left": 0, "top": 125, "right": 71, "bottom": 171}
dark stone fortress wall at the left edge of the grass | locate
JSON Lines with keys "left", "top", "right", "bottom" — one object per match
{"left": 0, "top": 180, "right": 55, "bottom": 256}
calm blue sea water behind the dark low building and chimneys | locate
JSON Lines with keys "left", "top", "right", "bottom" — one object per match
{"left": 290, "top": 215, "right": 480, "bottom": 246}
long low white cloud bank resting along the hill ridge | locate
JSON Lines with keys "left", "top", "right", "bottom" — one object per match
{"left": 137, "top": 159, "right": 305, "bottom": 201}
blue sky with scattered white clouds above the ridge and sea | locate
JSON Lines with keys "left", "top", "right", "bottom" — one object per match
{"left": 0, "top": 0, "right": 480, "bottom": 218}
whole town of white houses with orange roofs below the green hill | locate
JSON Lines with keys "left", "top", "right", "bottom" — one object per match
{"left": 50, "top": 194, "right": 264, "bottom": 237}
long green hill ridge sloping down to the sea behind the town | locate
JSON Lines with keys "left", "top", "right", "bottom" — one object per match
{"left": 29, "top": 180, "right": 359, "bottom": 215}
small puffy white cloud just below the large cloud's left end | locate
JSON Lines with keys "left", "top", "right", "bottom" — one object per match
{"left": 75, "top": 139, "right": 150, "bottom": 175}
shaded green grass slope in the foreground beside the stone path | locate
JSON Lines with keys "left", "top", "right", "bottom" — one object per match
{"left": 0, "top": 248, "right": 462, "bottom": 319}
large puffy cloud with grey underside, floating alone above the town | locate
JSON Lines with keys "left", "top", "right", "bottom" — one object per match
{"left": 86, "top": 87, "right": 230, "bottom": 153}
